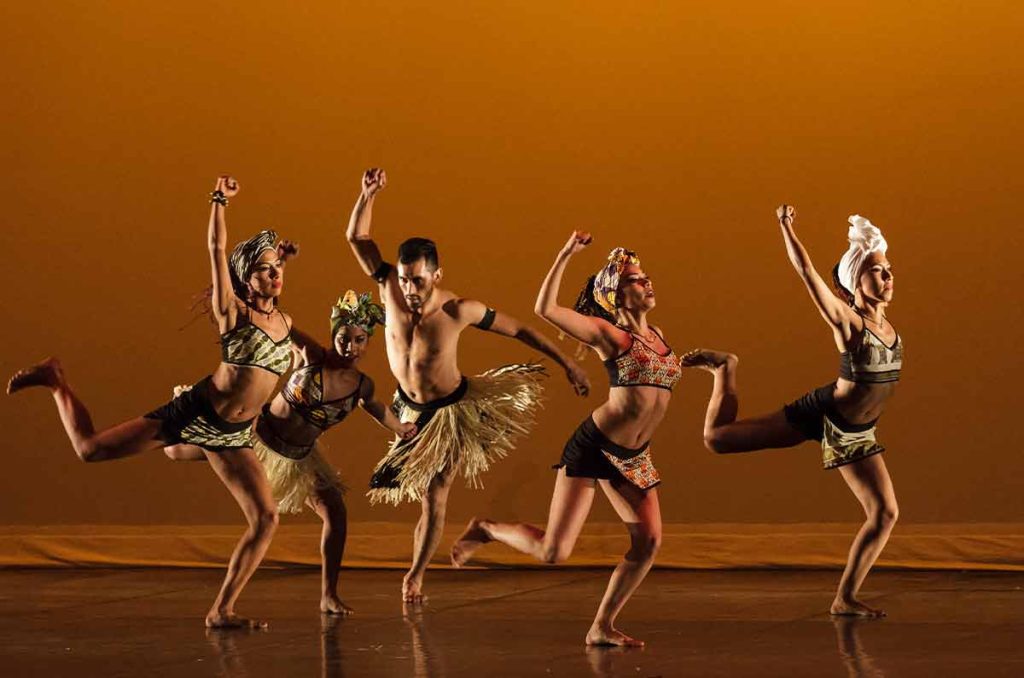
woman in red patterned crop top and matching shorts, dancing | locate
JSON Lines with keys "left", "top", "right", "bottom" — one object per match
{"left": 452, "top": 231, "right": 682, "bottom": 645}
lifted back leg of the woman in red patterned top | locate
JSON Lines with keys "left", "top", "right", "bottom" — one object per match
{"left": 452, "top": 468, "right": 594, "bottom": 567}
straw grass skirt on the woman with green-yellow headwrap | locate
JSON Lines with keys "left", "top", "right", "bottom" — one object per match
{"left": 253, "top": 433, "right": 345, "bottom": 513}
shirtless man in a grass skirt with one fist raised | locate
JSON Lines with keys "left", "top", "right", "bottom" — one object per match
{"left": 346, "top": 169, "right": 590, "bottom": 602}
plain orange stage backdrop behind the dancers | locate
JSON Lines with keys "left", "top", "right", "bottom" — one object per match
{"left": 0, "top": 1, "right": 1024, "bottom": 566}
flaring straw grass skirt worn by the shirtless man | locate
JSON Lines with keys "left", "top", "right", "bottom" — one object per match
{"left": 367, "top": 364, "right": 546, "bottom": 505}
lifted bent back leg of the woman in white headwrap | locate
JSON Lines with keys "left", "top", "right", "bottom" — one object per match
{"left": 682, "top": 349, "right": 804, "bottom": 454}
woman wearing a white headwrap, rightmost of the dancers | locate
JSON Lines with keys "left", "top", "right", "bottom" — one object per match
{"left": 683, "top": 205, "right": 903, "bottom": 617}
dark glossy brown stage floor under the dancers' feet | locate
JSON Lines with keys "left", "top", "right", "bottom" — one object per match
{"left": 0, "top": 568, "right": 1024, "bottom": 678}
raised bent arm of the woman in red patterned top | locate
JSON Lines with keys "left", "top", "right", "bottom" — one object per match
{"left": 534, "top": 230, "right": 617, "bottom": 357}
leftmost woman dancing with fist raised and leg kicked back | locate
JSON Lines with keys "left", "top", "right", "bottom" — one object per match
{"left": 7, "top": 176, "right": 301, "bottom": 627}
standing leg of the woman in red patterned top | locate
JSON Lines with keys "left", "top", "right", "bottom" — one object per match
{"left": 587, "top": 478, "right": 662, "bottom": 647}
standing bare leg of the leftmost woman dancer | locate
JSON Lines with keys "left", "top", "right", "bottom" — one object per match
{"left": 206, "top": 448, "right": 278, "bottom": 628}
